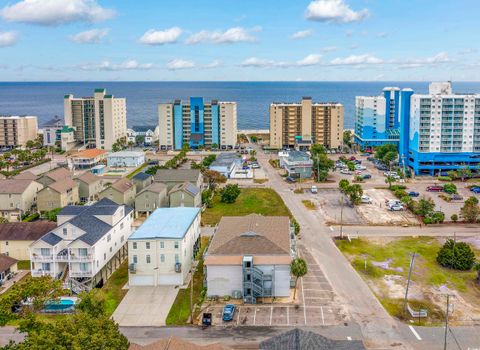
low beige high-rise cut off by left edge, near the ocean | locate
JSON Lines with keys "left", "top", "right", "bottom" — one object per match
{"left": 0, "top": 116, "right": 38, "bottom": 148}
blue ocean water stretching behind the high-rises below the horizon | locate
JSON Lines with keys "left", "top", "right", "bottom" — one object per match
{"left": 0, "top": 82, "right": 480, "bottom": 129}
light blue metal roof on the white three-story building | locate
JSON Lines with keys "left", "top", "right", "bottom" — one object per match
{"left": 129, "top": 207, "right": 200, "bottom": 240}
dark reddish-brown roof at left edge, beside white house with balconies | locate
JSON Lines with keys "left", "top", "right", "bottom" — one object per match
{"left": 0, "top": 221, "right": 57, "bottom": 241}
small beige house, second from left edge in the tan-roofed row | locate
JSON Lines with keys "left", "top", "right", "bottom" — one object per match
{"left": 37, "top": 177, "right": 80, "bottom": 211}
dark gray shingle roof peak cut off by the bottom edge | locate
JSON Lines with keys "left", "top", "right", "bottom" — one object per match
{"left": 260, "top": 328, "right": 365, "bottom": 350}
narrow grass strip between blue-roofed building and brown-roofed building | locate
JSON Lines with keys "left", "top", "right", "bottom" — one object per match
{"left": 165, "top": 237, "right": 209, "bottom": 326}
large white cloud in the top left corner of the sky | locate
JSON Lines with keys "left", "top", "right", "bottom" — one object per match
{"left": 0, "top": 0, "right": 115, "bottom": 26}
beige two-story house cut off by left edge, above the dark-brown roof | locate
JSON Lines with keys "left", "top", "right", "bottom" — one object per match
{"left": 0, "top": 179, "right": 43, "bottom": 222}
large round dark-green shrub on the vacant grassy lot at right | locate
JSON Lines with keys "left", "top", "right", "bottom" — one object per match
{"left": 437, "top": 239, "right": 475, "bottom": 271}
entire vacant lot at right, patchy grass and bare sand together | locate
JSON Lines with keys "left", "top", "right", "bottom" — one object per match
{"left": 336, "top": 237, "right": 480, "bottom": 325}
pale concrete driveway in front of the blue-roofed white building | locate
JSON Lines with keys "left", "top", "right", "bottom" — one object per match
{"left": 113, "top": 286, "right": 178, "bottom": 327}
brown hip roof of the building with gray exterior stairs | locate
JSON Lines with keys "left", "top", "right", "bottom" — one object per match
{"left": 208, "top": 214, "right": 290, "bottom": 255}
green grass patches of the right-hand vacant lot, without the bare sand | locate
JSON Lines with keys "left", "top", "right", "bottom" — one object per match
{"left": 336, "top": 237, "right": 480, "bottom": 324}
